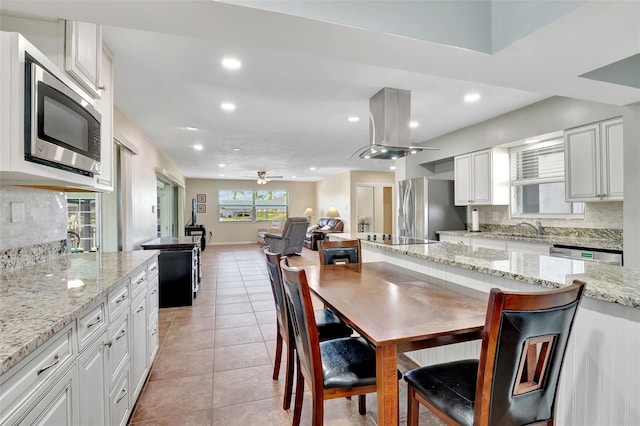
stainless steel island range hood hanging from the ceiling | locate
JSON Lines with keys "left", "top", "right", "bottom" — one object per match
{"left": 356, "top": 87, "right": 433, "bottom": 160}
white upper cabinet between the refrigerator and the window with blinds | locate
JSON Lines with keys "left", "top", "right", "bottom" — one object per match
{"left": 454, "top": 148, "right": 509, "bottom": 206}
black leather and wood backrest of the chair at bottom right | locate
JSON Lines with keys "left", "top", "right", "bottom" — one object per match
{"left": 474, "top": 280, "right": 584, "bottom": 425}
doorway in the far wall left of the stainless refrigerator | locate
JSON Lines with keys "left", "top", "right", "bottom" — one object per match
{"left": 356, "top": 184, "right": 393, "bottom": 234}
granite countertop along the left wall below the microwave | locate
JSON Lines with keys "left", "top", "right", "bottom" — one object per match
{"left": 0, "top": 250, "right": 159, "bottom": 375}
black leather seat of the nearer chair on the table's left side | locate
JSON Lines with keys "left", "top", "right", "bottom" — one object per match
{"left": 320, "top": 337, "right": 376, "bottom": 388}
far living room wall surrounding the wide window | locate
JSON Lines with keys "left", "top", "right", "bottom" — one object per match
{"left": 185, "top": 179, "right": 316, "bottom": 244}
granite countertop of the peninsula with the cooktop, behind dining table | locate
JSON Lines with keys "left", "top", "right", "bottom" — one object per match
{"left": 338, "top": 233, "right": 640, "bottom": 308}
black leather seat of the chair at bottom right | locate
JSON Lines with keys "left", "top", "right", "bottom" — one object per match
{"left": 404, "top": 359, "right": 478, "bottom": 426}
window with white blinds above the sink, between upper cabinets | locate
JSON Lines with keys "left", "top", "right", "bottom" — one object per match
{"left": 509, "top": 138, "right": 584, "bottom": 219}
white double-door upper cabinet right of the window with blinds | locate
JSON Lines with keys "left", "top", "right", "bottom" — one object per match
{"left": 564, "top": 118, "right": 623, "bottom": 201}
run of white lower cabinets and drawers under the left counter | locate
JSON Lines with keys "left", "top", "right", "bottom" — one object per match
{"left": 0, "top": 257, "right": 158, "bottom": 426}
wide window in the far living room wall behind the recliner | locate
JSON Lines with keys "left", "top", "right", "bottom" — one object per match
{"left": 218, "top": 191, "right": 288, "bottom": 222}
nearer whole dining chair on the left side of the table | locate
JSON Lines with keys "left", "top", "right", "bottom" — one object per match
{"left": 280, "top": 260, "right": 384, "bottom": 426}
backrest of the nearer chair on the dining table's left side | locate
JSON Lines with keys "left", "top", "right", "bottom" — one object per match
{"left": 280, "top": 260, "right": 323, "bottom": 394}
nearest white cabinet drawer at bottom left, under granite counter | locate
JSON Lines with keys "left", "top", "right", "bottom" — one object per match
{"left": 0, "top": 324, "right": 75, "bottom": 424}
